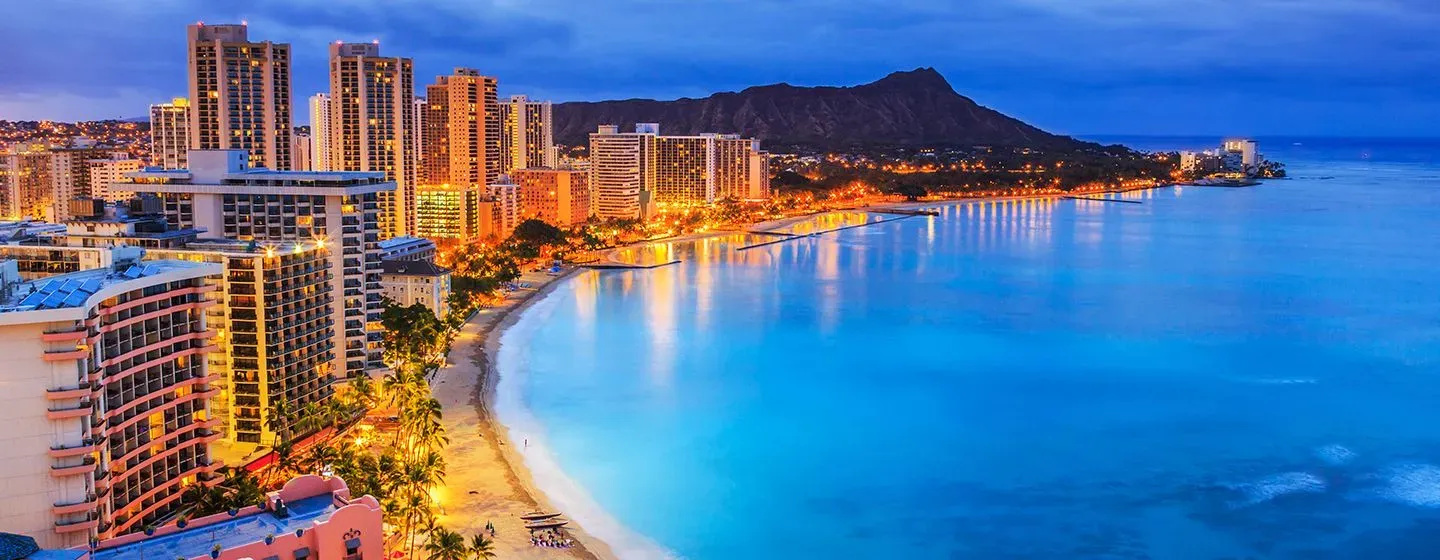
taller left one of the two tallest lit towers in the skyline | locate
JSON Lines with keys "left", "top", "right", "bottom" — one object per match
{"left": 187, "top": 23, "right": 292, "bottom": 170}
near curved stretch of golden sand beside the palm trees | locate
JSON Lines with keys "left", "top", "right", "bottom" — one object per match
{"left": 431, "top": 269, "right": 615, "bottom": 560}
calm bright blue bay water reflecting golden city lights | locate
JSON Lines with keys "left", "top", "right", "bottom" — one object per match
{"left": 500, "top": 138, "right": 1440, "bottom": 559}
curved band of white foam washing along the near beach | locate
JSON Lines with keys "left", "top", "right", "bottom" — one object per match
{"left": 495, "top": 289, "right": 677, "bottom": 560}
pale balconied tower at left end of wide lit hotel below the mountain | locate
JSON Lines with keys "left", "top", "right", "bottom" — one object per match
{"left": 590, "top": 125, "right": 655, "bottom": 219}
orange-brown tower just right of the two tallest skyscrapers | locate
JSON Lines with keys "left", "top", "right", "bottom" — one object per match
{"left": 420, "top": 68, "right": 501, "bottom": 187}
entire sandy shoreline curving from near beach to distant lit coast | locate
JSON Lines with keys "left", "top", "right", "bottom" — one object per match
{"left": 432, "top": 184, "right": 1172, "bottom": 560}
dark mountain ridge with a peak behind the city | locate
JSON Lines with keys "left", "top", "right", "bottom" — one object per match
{"left": 554, "top": 66, "right": 1097, "bottom": 150}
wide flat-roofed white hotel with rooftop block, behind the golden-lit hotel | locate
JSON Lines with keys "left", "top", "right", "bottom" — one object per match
{"left": 127, "top": 150, "right": 395, "bottom": 377}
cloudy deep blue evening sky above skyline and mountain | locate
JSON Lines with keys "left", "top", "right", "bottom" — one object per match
{"left": 0, "top": 0, "right": 1440, "bottom": 137}
